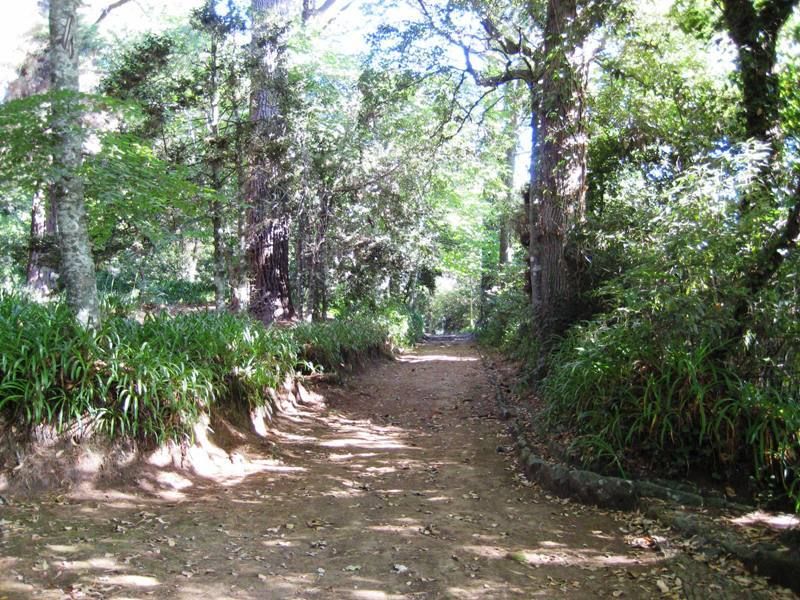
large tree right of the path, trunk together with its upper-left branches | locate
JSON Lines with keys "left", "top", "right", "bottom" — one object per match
{"left": 462, "top": 0, "right": 609, "bottom": 350}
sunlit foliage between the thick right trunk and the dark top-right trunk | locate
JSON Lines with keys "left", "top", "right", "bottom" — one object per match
{"left": 588, "top": 0, "right": 738, "bottom": 211}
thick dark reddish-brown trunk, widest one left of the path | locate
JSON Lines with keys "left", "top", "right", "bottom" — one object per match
{"left": 246, "top": 0, "right": 294, "bottom": 324}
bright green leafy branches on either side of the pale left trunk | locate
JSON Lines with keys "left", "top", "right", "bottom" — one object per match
{"left": 0, "top": 92, "right": 201, "bottom": 274}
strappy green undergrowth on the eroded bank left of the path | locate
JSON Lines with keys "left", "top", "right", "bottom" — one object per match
{"left": 0, "top": 294, "right": 416, "bottom": 442}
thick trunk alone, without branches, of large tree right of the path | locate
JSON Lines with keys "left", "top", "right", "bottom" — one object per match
{"left": 529, "top": 0, "right": 586, "bottom": 348}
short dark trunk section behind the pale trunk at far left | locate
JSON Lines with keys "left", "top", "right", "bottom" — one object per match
{"left": 26, "top": 188, "right": 58, "bottom": 297}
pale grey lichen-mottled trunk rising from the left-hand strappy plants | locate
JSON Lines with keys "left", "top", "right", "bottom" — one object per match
{"left": 50, "top": 0, "right": 100, "bottom": 327}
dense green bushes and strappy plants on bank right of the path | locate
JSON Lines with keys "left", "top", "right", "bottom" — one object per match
{"left": 542, "top": 146, "right": 800, "bottom": 501}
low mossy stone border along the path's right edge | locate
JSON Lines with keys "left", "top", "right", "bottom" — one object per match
{"left": 482, "top": 356, "right": 800, "bottom": 594}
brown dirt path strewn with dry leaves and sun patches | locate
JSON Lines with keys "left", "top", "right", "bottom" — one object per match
{"left": 0, "top": 342, "right": 788, "bottom": 599}
